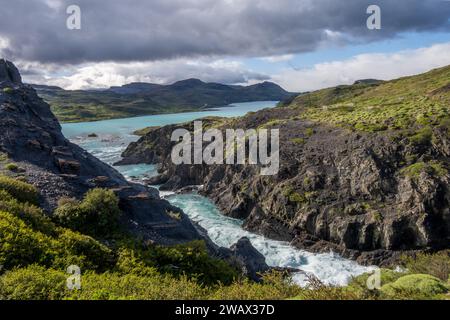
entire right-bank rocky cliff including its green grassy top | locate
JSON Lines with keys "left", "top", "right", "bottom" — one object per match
{"left": 118, "top": 68, "right": 450, "bottom": 265}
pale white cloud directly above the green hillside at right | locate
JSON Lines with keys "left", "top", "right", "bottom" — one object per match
{"left": 272, "top": 42, "right": 450, "bottom": 92}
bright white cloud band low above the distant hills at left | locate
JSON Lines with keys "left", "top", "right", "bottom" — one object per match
{"left": 19, "top": 59, "right": 269, "bottom": 90}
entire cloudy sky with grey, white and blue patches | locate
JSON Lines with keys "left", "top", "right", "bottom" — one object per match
{"left": 0, "top": 0, "right": 450, "bottom": 92}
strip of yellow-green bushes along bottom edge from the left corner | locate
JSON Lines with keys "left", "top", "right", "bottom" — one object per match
{"left": 0, "top": 266, "right": 299, "bottom": 300}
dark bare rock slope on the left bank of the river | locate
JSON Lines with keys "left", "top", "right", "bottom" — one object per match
{"left": 0, "top": 60, "right": 203, "bottom": 244}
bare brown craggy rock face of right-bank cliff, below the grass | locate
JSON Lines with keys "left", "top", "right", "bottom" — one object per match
{"left": 118, "top": 108, "right": 450, "bottom": 265}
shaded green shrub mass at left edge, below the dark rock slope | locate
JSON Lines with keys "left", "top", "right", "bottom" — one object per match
{"left": 0, "top": 208, "right": 114, "bottom": 271}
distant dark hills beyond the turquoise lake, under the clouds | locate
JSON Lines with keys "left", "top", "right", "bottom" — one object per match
{"left": 33, "top": 79, "right": 293, "bottom": 122}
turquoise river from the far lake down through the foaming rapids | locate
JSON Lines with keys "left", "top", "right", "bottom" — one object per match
{"left": 62, "top": 101, "right": 372, "bottom": 285}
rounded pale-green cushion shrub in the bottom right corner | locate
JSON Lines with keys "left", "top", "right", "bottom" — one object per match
{"left": 381, "top": 274, "right": 448, "bottom": 299}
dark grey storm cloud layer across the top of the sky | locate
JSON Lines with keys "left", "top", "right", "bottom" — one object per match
{"left": 0, "top": 0, "right": 450, "bottom": 63}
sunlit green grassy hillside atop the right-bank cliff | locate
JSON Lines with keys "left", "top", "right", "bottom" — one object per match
{"left": 288, "top": 66, "right": 450, "bottom": 131}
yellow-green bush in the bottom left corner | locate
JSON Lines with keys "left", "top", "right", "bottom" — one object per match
{"left": 0, "top": 265, "right": 67, "bottom": 300}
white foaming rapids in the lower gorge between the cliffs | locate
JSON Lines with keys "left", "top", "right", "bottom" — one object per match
{"left": 166, "top": 194, "right": 372, "bottom": 285}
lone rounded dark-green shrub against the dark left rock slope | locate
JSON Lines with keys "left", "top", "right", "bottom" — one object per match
{"left": 55, "top": 189, "right": 121, "bottom": 236}
